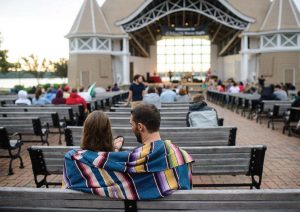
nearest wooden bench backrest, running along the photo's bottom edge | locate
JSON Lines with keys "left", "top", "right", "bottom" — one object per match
{"left": 0, "top": 187, "right": 300, "bottom": 212}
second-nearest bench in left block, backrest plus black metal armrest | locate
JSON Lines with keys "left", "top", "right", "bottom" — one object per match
{"left": 0, "top": 116, "right": 49, "bottom": 145}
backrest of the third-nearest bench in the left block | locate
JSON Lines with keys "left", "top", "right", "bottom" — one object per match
{"left": 0, "top": 111, "right": 59, "bottom": 127}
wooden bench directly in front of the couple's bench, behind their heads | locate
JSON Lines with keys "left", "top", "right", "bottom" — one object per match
{"left": 65, "top": 126, "right": 237, "bottom": 146}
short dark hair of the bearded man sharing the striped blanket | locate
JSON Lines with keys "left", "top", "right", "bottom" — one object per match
{"left": 131, "top": 104, "right": 160, "bottom": 133}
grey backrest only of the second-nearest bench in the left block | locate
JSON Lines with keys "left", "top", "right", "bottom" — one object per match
{"left": 0, "top": 116, "right": 42, "bottom": 135}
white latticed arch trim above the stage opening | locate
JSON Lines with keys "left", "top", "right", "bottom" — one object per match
{"left": 117, "top": 0, "right": 249, "bottom": 32}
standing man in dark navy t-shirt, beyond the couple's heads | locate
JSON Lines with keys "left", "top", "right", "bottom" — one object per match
{"left": 127, "top": 74, "right": 145, "bottom": 109}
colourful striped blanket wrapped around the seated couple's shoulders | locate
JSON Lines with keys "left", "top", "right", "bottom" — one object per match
{"left": 63, "top": 140, "right": 193, "bottom": 200}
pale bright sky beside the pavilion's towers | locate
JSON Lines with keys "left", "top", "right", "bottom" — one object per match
{"left": 0, "top": 0, "right": 300, "bottom": 62}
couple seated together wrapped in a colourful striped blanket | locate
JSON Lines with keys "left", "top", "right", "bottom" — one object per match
{"left": 63, "top": 105, "right": 193, "bottom": 200}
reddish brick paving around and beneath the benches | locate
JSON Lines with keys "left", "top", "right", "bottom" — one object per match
{"left": 0, "top": 105, "right": 300, "bottom": 189}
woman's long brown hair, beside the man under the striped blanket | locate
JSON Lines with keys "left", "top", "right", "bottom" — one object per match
{"left": 80, "top": 111, "right": 114, "bottom": 152}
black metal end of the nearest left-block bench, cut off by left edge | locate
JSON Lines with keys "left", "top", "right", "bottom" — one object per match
{"left": 0, "top": 127, "right": 24, "bottom": 175}
